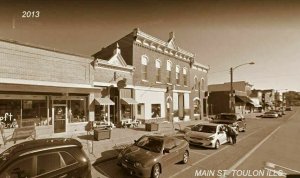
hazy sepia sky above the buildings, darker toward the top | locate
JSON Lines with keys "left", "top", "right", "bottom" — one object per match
{"left": 0, "top": 0, "right": 300, "bottom": 91}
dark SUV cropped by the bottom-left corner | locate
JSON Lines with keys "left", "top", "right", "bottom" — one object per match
{"left": 0, "top": 138, "right": 91, "bottom": 178}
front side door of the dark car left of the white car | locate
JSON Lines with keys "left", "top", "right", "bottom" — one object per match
{"left": 163, "top": 138, "right": 179, "bottom": 165}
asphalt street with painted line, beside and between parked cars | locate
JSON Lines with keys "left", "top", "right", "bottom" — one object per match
{"left": 94, "top": 108, "right": 300, "bottom": 178}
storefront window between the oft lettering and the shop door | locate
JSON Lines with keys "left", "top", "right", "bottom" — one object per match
{"left": 22, "top": 100, "right": 49, "bottom": 126}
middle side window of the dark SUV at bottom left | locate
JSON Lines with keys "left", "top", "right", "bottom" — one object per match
{"left": 37, "top": 153, "right": 64, "bottom": 175}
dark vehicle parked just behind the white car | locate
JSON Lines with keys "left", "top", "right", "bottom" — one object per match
{"left": 211, "top": 113, "right": 247, "bottom": 132}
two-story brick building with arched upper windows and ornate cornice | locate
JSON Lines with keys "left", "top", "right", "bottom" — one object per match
{"left": 93, "top": 29, "right": 209, "bottom": 121}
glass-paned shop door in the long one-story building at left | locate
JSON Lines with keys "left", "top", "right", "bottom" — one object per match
{"left": 53, "top": 106, "right": 67, "bottom": 133}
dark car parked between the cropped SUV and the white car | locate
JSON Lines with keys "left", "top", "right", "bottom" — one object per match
{"left": 118, "top": 135, "right": 189, "bottom": 178}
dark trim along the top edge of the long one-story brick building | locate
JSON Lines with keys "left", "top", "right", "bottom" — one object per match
{"left": 0, "top": 38, "right": 93, "bottom": 60}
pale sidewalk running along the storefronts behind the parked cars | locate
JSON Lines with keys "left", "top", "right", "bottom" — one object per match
{"left": 0, "top": 120, "right": 207, "bottom": 177}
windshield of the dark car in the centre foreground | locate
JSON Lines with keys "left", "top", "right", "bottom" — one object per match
{"left": 135, "top": 137, "right": 163, "bottom": 153}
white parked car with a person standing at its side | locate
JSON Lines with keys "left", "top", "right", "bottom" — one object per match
{"left": 185, "top": 123, "right": 228, "bottom": 149}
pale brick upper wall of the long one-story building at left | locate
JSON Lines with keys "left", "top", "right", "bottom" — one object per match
{"left": 0, "top": 41, "right": 92, "bottom": 84}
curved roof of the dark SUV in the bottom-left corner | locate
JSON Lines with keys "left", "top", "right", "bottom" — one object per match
{"left": 0, "top": 138, "right": 82, "bottom": 165}
